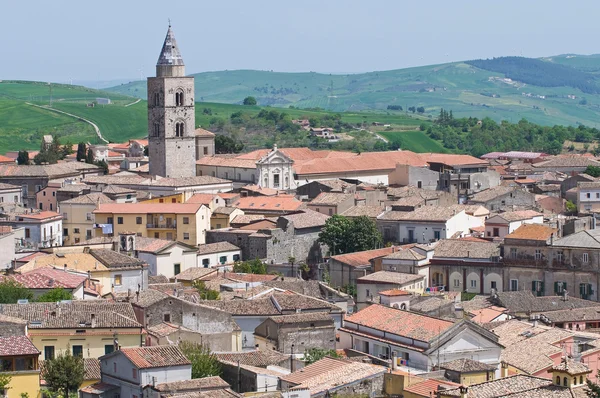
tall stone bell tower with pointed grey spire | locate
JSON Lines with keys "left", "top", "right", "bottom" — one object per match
{"left": 148, "top": 24, "right": 196, "bottom": 178}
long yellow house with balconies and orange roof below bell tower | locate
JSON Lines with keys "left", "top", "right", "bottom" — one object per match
{"left": 94, "top": 202, "right": 210, "bottom": 245}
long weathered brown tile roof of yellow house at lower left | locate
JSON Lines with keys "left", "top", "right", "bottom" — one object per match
{"left": 0, "top": 300, "right": 141, "bottom": 329}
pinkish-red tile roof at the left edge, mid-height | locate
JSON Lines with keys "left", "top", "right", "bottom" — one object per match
{"left": 0, "top": 267, "right": 87, "bottom": 289}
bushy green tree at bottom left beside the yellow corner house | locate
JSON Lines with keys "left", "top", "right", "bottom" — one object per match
{"left": 41, "top": 347, "right": 84, "bottom": 397}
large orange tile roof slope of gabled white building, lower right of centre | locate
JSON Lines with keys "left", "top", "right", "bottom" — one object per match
{"left": 345, "top": 304, "right": 454, "bottom": 342}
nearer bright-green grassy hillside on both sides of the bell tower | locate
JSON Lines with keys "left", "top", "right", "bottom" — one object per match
{"left": 0, "top": 81, "right": 440, "bottom": 153}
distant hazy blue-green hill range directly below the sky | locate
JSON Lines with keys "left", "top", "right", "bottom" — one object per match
{"left": 107, "top": 55, "right": 600, "bottom": 127}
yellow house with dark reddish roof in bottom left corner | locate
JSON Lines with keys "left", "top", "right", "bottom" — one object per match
{"left": 0, "top": 335, "right": 40, "bottom": 398}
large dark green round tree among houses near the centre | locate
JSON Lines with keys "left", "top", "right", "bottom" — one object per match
{"left": 319, "top": 214, "right": 383, "bottom": 255}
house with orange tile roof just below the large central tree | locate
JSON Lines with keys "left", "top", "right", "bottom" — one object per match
{"left": 327, "top": 247, "right": 395, "bottom": 287}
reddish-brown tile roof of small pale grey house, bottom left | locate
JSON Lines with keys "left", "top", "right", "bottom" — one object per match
{"left": 116, "top": 345, "right": 191, "bottom": 369}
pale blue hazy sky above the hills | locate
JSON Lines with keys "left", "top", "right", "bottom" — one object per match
{"left": 0, "top": 0, "right": 600, "bottom": 84}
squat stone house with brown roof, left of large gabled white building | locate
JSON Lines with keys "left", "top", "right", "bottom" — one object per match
{"left": 254, "top": 312, "right": 335, "bottom": 354}
